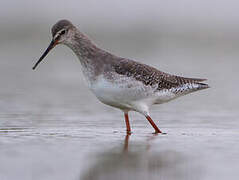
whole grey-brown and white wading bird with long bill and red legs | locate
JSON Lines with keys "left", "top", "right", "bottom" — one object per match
{"left": 33, "top": 20, "right": 209, "bottom": 134}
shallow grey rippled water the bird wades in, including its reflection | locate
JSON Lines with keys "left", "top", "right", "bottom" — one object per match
{"left": 0, "top": 27, "right": 239, "bottom": 180}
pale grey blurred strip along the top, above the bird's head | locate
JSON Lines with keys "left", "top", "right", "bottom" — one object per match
{"left": 0, "top": 0, "right": 239, "bottom": 25}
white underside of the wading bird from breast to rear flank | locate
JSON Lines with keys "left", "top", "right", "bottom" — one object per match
{"left": 90, "top": 75, "right": 177, "bottom": 113}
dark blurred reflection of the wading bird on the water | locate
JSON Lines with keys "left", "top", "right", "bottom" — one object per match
{"left": 80, "top": 135, "right": 200, "bottom": 180}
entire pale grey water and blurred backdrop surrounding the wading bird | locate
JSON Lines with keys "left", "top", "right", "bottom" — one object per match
{"left": 0, "top": 0, "right": 239, "bottom": 180}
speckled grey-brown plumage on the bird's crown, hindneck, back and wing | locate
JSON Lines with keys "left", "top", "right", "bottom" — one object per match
{"left": 49, "top": 20, "right": 208, "bottom": 93}
